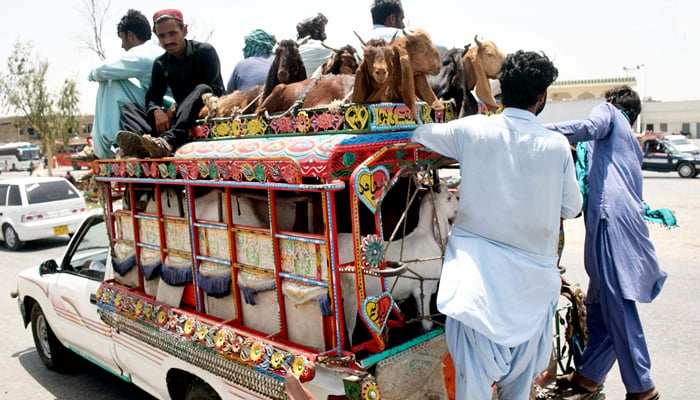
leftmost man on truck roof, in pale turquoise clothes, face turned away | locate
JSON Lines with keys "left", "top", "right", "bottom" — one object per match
{"left": 70, "top": 9, "right": 163, "bottom": 161}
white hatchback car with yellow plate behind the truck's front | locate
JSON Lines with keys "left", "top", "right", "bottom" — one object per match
{"left": 0, "top": 177, "right": 87, "bottom": 250}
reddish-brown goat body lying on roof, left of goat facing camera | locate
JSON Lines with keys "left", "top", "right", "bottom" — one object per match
{"left": 256, "top": 74, "right": 355, "bottom": 114}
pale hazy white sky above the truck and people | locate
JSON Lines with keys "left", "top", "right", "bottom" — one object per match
{"left": 0, "top": 0, "right": 700, "bottom": 115}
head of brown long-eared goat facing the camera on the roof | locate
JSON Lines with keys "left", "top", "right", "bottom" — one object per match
{"left": 352, "top": 36, "right": 394, "bottom": 103}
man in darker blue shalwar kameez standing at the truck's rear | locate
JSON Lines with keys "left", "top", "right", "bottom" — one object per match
{"left": 547, "top": 86, "right": 666, "bottom": 400}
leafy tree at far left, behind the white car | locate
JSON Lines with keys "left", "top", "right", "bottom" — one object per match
{"left": 0, "top": 41, "right": 79, "bottom": 175}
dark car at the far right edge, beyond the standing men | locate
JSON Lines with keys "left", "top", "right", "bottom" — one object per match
{"left": 642, "top": 139, "right": 700, "bottom": 178}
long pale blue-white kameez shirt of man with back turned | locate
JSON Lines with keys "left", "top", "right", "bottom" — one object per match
{"left": 412, "top": 108, "right": 582, "bottom": 346}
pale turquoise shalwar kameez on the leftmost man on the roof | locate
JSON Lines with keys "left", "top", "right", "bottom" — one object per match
{"left": 88, "top": 41, "right": 164, "bottom": 158}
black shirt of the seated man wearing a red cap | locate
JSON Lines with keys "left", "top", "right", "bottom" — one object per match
{"left": 146, "top": 40, "right": 224, "bottom": 114}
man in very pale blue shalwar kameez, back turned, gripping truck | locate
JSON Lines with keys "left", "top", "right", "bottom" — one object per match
{"left": 413, "top": 50, "right": 582, "bottom": 400}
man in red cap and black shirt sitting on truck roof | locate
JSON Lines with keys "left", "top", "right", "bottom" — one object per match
{"left": 117, "top": 9, "right": 225, "bottom": 158}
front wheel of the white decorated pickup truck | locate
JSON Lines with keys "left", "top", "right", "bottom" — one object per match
{"left": 32, "top": 304, "right": 73, "bottom": 372}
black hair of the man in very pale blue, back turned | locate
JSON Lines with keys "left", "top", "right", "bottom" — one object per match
{"left": 498, "top": 50, "right": 559, "bottom": 109}
